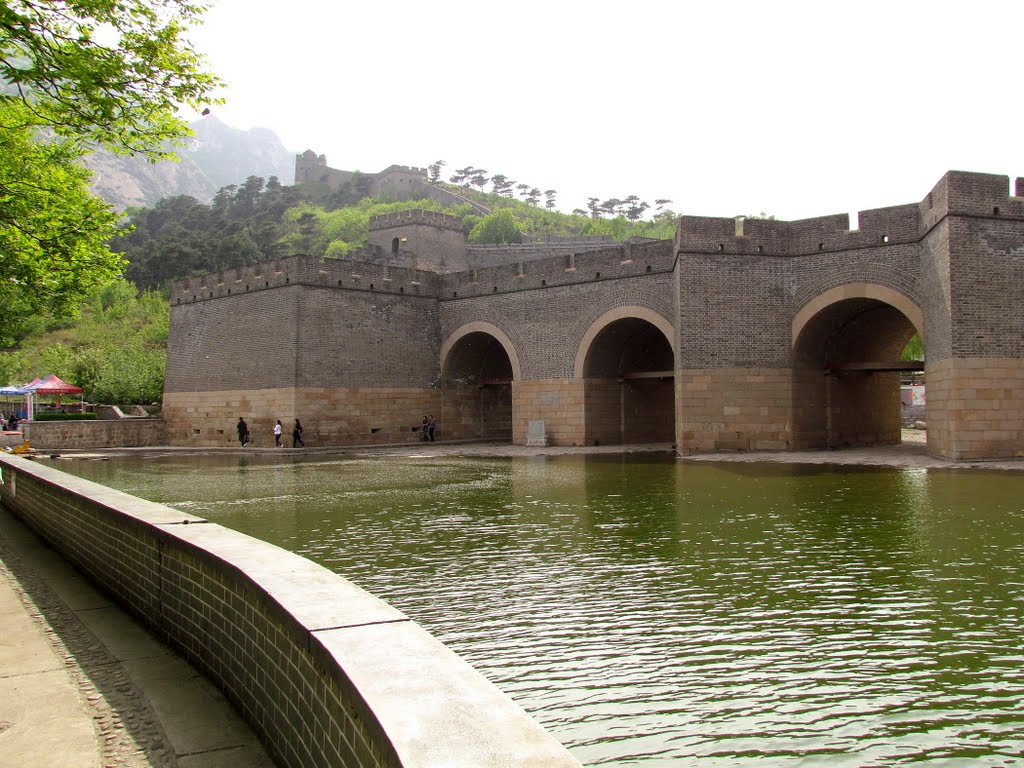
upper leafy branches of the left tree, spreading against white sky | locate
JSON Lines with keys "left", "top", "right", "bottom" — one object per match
{"left": 0, "top": 0, "right": 220, "bottom": 159}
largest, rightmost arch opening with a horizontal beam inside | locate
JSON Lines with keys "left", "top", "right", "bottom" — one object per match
{"left": 793, "top": 292, "right": 921, "bottom": 450}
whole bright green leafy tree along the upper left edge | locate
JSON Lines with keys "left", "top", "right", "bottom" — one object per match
{"left": 0, "top": 0, "right": 219, "bottom": 329}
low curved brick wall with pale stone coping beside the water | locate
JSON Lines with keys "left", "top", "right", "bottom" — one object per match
{"left": 0, "top": 457, "right": 579, "bottom": 768}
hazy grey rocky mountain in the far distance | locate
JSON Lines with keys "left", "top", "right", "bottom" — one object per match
{"left": 87, "top": 116, "right": 295, "bottom": 210}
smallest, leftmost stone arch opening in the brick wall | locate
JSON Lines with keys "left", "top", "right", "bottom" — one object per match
{"left": 441, "top": 330, "right": 517, "bottom": 440}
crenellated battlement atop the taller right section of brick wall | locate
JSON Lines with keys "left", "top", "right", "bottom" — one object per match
{"left": 676, "top": 171, "right": 1024, "bottom": 256}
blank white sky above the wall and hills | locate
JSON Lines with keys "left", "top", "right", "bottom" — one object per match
{"left": 186, "top": 0, "right": 1024, "bottom": 220}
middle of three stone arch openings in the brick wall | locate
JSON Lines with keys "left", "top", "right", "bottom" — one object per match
{"left": 577, "top": 316, "right": 676, "bottom": 445}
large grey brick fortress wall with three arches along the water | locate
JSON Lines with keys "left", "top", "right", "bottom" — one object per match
{"left": 164, "top": 167, "right": 1024, "bottom": 460}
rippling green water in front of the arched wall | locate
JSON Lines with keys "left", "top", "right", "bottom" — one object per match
{"left": 59, "top": 456, "right": 1024, "bottom": 768}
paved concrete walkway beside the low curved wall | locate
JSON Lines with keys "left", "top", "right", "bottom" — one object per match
{"left": 0, "top": 507, "right": 273, "bottom": 768}
